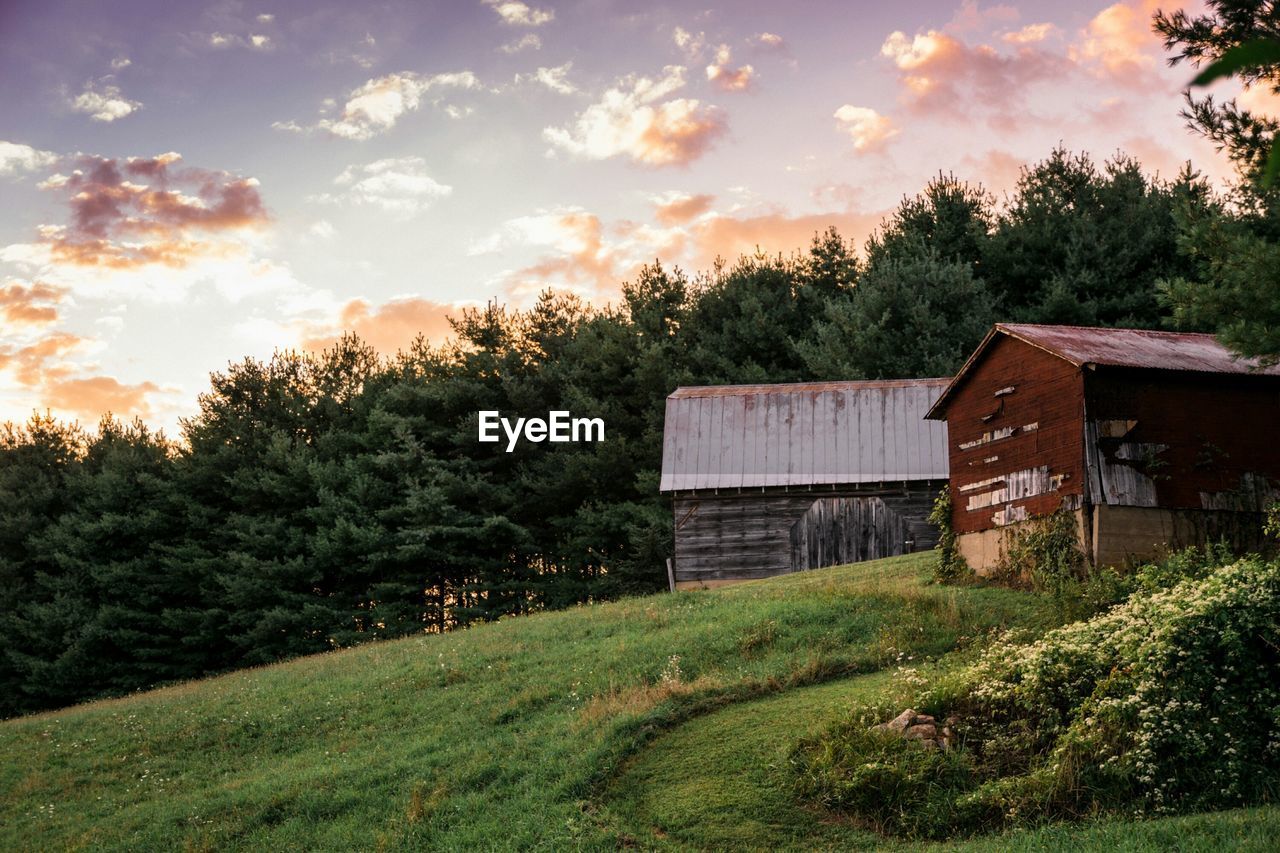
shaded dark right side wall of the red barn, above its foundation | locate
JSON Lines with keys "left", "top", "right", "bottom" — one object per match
{"left": 1084, "top": 368, "right": 1280, "bottom": 512}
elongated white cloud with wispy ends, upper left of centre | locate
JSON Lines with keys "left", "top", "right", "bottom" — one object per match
{"left": 271, "top": 70, "right": 480, "bottom": 140}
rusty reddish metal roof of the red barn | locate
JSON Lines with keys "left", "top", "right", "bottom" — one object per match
{"left": 927, "top": 323, "right": 1280, "bottom": 419}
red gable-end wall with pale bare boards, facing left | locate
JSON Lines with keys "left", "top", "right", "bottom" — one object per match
{"left": 947, "top": 336, "right": 1085, "bottom": 534}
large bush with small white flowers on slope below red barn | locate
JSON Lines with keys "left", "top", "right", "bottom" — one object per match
{"left": 794, "top": 558, "right": 1280, "bottom": 838}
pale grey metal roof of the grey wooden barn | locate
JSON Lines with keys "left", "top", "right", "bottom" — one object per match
{"left": 660, "top": 379, "right": 947, "bottom": 492}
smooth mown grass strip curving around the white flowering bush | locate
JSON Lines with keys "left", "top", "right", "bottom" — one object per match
{"left": 605, "top": 672, "right": 1280, "bottom": 853}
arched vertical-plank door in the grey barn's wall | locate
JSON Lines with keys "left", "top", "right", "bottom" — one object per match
{"left": 791, "top": 497, "right": 909, "bottom": 571}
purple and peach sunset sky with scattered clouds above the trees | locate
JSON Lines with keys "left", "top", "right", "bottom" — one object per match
{"left": 0, "top": 0, "right": 1259, "bottom": 435}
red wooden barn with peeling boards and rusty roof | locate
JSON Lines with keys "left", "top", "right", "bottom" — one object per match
{"left": 928, "top": 324, "right": 1280, "bottom": 573}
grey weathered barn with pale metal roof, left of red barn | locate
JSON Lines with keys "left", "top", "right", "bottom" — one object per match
{"left": 660, "top": 379, "right": 947, "bottom": 588}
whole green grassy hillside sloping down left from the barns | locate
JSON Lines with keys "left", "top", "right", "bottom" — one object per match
{"left": 0, "top": 555, "right": 1280, "bottom": 849}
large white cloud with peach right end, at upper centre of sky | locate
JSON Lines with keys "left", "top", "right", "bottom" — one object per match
{"left": 543, "top": 65, "right": 726, "bottom": 167}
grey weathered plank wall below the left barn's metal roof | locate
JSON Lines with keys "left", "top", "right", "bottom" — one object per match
{"left": 673, "top": 480, "right": 945, "bottom": 583}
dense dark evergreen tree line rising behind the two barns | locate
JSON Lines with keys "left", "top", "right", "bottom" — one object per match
{"left": 0, "top": 142, "right": 1276, "bottom": 715}
